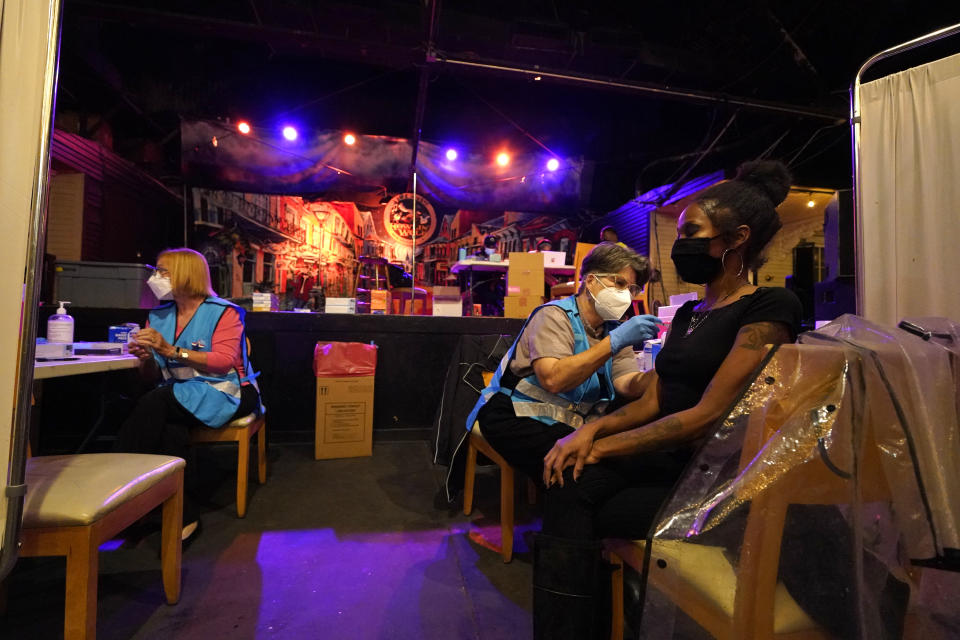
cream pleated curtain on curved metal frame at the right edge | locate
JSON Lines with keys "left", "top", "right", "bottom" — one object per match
{"left": 858, "top": 54, "right": 960, "bottom": 324}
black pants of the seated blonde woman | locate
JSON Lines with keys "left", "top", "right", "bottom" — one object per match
{"left": 114, "top": 385, "right": 259, "bottom": 522}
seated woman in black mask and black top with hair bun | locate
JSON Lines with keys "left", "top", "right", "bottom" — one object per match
{"left": 534, "top": 161, "right": 801, "bottom": 638}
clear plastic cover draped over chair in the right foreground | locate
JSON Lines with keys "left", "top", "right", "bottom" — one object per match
{"left": 636, "top": 316, "right": 960, "bottom": 639}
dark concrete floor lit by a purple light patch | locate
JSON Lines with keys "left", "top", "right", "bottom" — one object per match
{"left": 0, "top": 441, "right": 539, "bottom": 640}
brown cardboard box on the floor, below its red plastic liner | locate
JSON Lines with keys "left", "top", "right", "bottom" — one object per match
{"left": 313, "top": 376, "right": 374, "bottom": 460}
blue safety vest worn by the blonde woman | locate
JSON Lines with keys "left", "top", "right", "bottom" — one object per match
{"left": 149, "top": 297, "right": 263, "bottom": 427}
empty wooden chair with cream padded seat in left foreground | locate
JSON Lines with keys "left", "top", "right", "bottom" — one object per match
{"left": 20, "top": 453, "right": 184, "bottom": 640}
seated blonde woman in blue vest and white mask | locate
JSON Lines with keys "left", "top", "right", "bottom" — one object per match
{"left": 116, "top": 248, "right": 261, "bottom": 540}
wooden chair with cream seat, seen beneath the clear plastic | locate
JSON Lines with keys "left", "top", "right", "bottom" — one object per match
{"left": 604, "top": 345, "right": 890, "bottom": 640}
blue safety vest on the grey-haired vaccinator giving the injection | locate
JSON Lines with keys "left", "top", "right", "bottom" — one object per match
{"left": 467, "top": 296, "right": 614, "bottom": 431}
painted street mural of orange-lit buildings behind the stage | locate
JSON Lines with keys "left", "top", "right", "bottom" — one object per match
{"left": 190, "top": 188, "right": 579, "bottom": 309}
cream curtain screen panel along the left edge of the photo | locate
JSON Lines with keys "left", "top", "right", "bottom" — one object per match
{"left": 0, "top": 0, "right": 60, "bottom": 556}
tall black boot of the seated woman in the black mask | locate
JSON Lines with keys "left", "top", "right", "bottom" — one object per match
{"left": 533, "top": 534, "right": 610, "bottom": 640}
